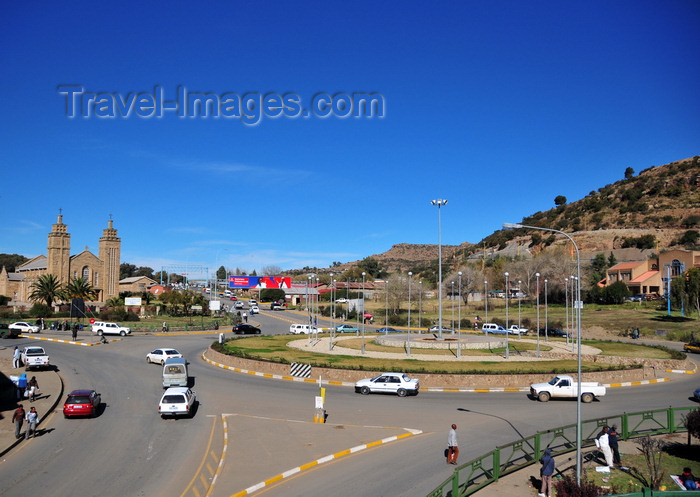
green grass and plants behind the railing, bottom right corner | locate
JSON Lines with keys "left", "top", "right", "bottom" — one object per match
{"left": 585, "top": 443, "right": 700, "bottom": 493}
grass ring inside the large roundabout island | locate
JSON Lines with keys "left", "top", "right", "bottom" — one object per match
{"left": 216, "top": 335, "right": 669, "bottom": 374}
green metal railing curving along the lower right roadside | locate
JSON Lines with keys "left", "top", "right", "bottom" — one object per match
{"left": 428, "top": 407, "right": 697, "bottom": 497}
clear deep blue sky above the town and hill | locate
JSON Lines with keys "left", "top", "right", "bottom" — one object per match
{"left": 0, "top": 0, "right": 700, "bottom": 271}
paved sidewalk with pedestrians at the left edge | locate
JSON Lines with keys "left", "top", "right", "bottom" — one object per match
{"left": 0, "top": 340, "right": 64, "bottom": 456}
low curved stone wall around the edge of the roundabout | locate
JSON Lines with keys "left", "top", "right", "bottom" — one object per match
{"left": 206, "top": 348, "right": 692, "bottom": 388}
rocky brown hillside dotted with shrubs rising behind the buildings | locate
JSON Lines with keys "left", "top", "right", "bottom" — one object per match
{"left": 326, "top": 156, "right": 700, "bottom": 272}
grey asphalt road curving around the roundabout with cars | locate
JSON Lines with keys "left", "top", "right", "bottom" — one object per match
{"left": 0, "top": 311, "right": 698, "bottom": 497}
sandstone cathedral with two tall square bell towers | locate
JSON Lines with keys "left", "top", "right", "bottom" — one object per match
{"left": 0, "top": 214, "right": 121, "bottom": 306}
